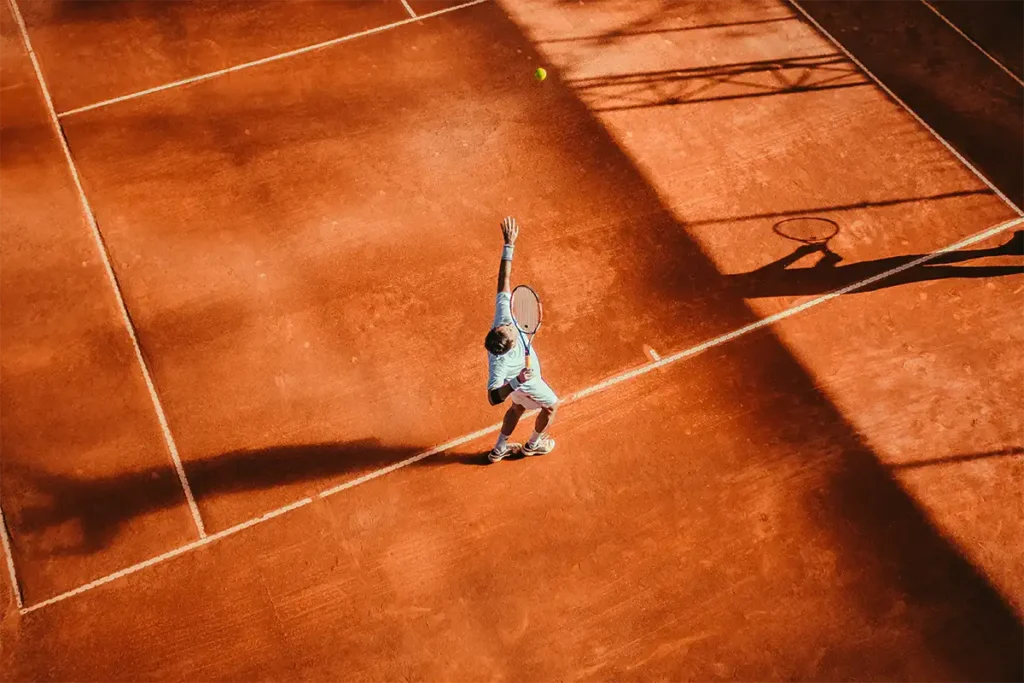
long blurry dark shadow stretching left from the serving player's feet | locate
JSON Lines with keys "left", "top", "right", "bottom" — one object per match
{"left": 12, "top": 439, "right": 426, "bottom": 554}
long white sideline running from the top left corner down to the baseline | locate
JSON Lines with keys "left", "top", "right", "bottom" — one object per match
{"left": 9, "top": 0, "right": 206, "bottom": 538}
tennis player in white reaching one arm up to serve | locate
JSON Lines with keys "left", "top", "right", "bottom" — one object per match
{"left": 483, "top": 218, "right": 558, "bottom": 463}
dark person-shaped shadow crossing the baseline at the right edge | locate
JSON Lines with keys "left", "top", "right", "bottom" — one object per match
{"left": 722, "top": 222, "right": 1024, "bottom": 299}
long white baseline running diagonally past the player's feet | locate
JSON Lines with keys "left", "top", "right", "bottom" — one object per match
{"left": 20, "top": 217, "right": 1024, "bottom": 614}
